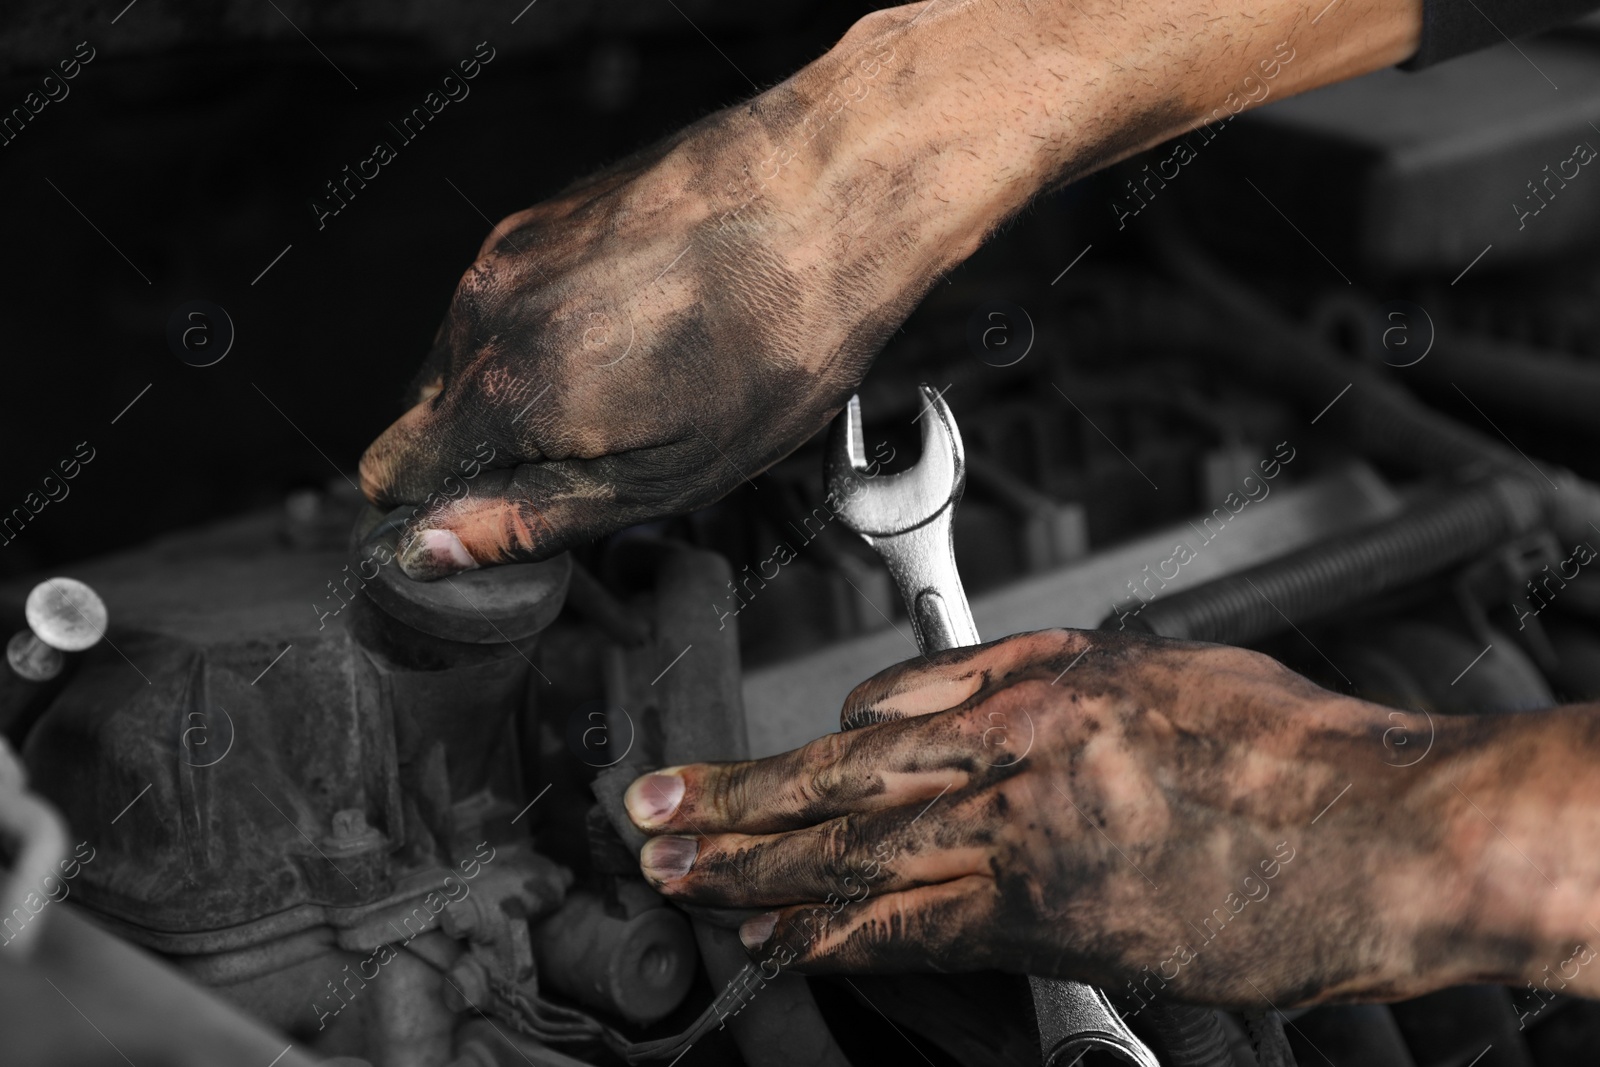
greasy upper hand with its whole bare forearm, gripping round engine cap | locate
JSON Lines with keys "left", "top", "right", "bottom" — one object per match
{"left": 362, "top": 0, "right": 1421, "bottom": 577}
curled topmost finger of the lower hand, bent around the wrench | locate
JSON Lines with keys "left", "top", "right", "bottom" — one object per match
{"left": 838, "top": 630, "right": 1088, "bottom": 729}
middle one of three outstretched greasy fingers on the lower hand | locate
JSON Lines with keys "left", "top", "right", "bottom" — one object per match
{"left": 640, "top": 800, "right": 990, "bottom": 907}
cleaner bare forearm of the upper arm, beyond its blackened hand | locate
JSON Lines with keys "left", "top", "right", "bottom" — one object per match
{"left": 757, "top": 0, "right": 1422, "bottom": 269}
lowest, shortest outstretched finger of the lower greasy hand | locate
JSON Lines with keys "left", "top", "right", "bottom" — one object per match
{"left": 739, "top": 875, "right": 998, "bottom": 973}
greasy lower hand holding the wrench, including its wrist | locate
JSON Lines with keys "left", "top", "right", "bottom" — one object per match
{"left": 627, "top": 630, "right": 1600, "bottom": 1008}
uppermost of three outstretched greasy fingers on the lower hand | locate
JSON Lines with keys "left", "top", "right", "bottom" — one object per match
{"left": 626, "top": 717, "right": 981, "bottom": 835}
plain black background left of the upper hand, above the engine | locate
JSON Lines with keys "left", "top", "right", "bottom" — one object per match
{"left": 0, "top": 0, "right": 875, "bottom": 574}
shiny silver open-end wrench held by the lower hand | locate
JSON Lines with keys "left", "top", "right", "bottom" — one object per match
{"left": 826, "top": 386, "right": 1160, "bottom": 1067}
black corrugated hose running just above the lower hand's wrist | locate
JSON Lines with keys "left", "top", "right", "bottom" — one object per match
{"left": 1101, "top": 475, "right": 1546, "bottom": 645}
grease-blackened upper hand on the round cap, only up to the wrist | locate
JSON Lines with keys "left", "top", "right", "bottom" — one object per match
{"left": 362, "top": 10, "right": 984, "bottom": 579}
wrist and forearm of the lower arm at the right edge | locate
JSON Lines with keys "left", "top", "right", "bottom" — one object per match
{"left": 1293, "top": 694, "right": 1600, "bottom": 1000}
